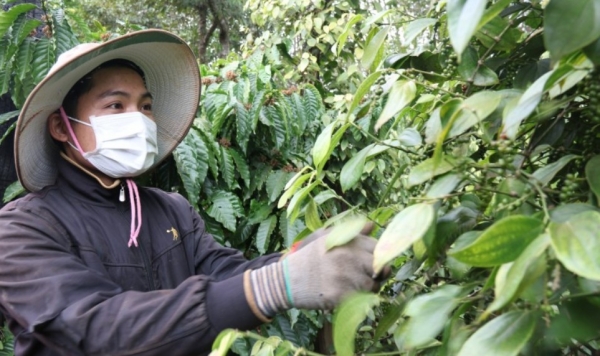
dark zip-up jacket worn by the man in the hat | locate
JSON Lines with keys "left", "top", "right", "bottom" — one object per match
{"left": 0, "top": 159, "right": 279, "bottom": 355}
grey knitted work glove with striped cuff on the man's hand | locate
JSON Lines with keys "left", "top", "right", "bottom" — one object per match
{"left": 245, "top": 222, "right": 389, "bottom": 320}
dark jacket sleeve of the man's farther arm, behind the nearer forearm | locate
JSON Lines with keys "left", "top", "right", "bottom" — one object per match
{"left": 188, "top": 204, "right": 281, "bottom": 280}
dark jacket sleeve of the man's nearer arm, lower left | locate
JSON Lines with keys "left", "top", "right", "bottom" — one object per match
{"left": 0, "top": 205, "right": 260, "bottom": 355}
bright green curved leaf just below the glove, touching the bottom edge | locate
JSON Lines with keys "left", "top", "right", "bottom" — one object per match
{"left": 333, "top": 293, "right": 379, "bottom": 356}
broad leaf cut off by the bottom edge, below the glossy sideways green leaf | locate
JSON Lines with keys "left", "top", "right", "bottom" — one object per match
{"left": 458, "top": 310, "right": 536, "bottom": 356}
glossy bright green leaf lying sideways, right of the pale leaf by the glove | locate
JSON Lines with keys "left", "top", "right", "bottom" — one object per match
{"left": 448, "top": 215, "right": 543, "bottom": 267}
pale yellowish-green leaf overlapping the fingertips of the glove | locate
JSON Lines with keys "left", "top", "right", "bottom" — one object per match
{"left": 373, "top": 203, "right": 435, "bottom": 273}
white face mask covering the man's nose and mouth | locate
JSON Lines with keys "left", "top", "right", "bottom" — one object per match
{"left": 61, "top": 110, "right": 158, "bottom": 178}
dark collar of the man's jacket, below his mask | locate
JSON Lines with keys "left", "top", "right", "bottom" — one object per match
{"left": 56, "top": 152, "right": 121, "bottom": 205}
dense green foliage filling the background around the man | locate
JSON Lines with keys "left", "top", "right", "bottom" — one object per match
{"left": 0, "top": 0, "right": 600, "bottom": 356}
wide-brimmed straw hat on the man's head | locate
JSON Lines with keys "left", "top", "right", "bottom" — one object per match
{"left": 15, "top": 30, "right": 200, "bottom": 191}
